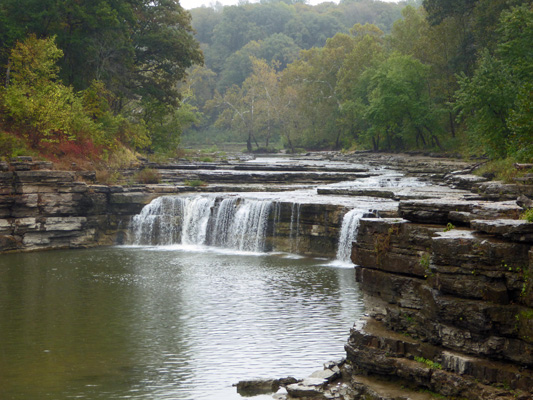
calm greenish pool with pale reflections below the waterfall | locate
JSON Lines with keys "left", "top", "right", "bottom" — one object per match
{"left": 0, "top": 247, "right": 362, "bottom": 400}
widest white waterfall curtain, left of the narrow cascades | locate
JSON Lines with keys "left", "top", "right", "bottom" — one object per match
{"left": 130, "top": 195, "right": 272, "bottom": 252}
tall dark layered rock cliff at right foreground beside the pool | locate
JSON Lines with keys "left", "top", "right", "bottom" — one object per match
{"left": 346, "top": 214, "right": 533, "bottom": 400}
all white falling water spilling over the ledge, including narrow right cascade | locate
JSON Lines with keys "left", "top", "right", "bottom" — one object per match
{"left": 130, "top": 195, "right": 364, "bottom": 264}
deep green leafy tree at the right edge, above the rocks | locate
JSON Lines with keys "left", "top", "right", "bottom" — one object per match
{"left": 456, "top": 5, "right": 533, "bottom": 160}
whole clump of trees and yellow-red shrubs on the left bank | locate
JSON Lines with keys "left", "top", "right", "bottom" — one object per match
{"left": 0, "top": 0, "right": 203, "bottom": 164}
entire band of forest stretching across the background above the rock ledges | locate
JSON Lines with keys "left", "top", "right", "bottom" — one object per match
{"left": 0, "top": 0, "right": 533, "bottom": 167}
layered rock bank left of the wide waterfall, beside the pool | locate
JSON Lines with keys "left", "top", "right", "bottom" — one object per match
{"left": 0, "top": 158, "right": 153, "bottom": 252}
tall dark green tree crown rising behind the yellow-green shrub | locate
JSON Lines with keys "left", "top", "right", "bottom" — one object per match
{"left": 0, "top": 0, "right": 202, "bottom": 109}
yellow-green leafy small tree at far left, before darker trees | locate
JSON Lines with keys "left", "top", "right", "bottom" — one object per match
{"left": 0, "top": 36, "right": 103, "bottom": 148}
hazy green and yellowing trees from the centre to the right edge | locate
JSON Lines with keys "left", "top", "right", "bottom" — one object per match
{"left": 186, "top": 0, "right": 533, "bottom": 161}
